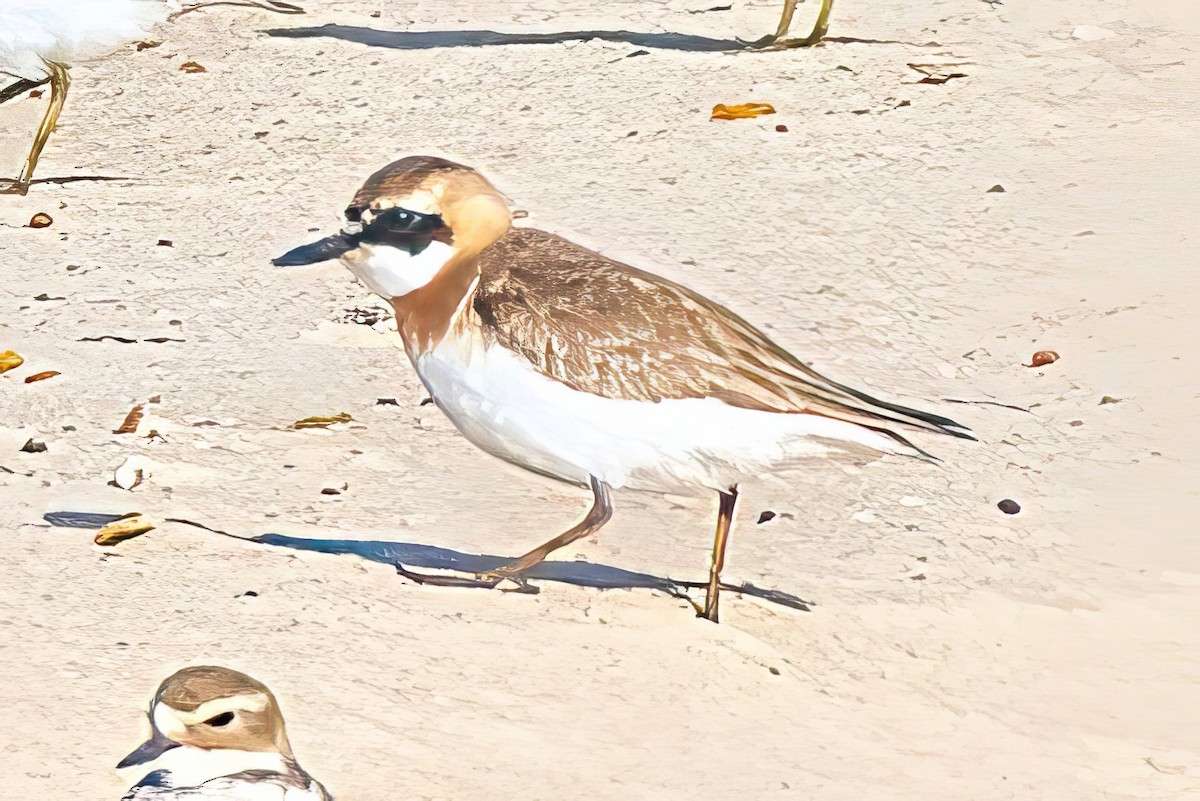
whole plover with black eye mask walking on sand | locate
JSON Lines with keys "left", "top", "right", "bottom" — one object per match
{"left": 274, "top": 156, "right": 973, "bottom": 621}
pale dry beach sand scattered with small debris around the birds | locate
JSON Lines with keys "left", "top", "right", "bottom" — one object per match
{"left": 0, "top": 0, "right": 1200, "bottom": 801}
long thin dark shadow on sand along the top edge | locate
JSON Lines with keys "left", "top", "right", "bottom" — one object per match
{"left": 265, "top": 24, "right": 763, "bottom": 53}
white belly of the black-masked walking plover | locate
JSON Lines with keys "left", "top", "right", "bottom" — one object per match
{"left": 414, "top": 337, "right": 898, "bottom": 493}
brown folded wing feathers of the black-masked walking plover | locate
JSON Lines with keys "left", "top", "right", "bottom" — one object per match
{"left": 474, "top": 229, "right": 974, "bottom": 452}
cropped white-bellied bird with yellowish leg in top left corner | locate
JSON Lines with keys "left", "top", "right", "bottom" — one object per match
{"left": 0, "top": 0, "right": 302, "bottom": 194}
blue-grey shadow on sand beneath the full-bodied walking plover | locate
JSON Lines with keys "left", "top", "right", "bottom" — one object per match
{"left": 43, "top": 512, "right": 811, "bottom": 612}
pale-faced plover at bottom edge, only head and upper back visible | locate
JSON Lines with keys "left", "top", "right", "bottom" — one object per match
{"left": 116, "top": 666, "right": 332, "bottom": 801}
